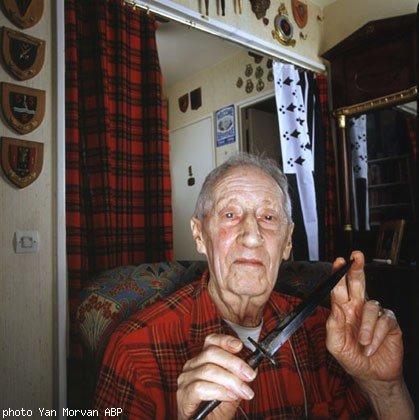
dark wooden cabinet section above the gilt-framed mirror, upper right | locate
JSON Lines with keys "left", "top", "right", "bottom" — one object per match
{"left": 322, "top": 14, "right": 417, "bottom": 109}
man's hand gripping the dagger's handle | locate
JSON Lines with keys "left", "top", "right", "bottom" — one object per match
{"left": 176, "top": 334, "right": 256, "bottom": 419}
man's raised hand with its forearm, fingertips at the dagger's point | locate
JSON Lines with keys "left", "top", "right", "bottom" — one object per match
{"left": 326, "top": 251, "right": 413, "bottom": 418}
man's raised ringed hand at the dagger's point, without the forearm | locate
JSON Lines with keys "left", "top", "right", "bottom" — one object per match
{"left": 326, "top": 251, "right": 403, "bottom": 381}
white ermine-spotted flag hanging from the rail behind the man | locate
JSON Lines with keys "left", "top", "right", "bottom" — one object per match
{"left": 273, "top": 62, "right": 319, "bottom": 261}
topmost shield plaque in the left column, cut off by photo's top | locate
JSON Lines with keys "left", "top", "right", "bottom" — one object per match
{"left": 1, "top": 0, "right": 44, "bottom": 29}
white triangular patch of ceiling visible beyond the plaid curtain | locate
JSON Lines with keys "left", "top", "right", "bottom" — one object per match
{"left": 156, "top": 22, "right": 243, "bottom": 88}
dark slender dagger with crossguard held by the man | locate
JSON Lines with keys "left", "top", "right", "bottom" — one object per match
{"left": 192, "top": 260, "right": 353, "bottom": 420}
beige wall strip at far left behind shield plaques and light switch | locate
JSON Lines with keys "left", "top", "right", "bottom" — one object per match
{"left": 0, "top": 0, "right": 56, "bottom": 418}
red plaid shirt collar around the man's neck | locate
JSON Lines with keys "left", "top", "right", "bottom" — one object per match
{"left": 189, "top": 270, "right": 291, "bottom": 355}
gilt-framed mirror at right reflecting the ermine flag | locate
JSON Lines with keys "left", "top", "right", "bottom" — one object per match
{"left": 334, "top": 86, "right": 417, "bottom": 264}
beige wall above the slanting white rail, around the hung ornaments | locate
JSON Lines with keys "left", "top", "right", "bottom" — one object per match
{"left": 174, "top": 0, "right": 323, "bottom": 63}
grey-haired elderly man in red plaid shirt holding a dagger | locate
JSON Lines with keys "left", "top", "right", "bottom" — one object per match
{"left": 96, "top": 154, "right": 413, "bottom": 419}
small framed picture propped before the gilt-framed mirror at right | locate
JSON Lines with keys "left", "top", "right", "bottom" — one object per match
{"left": 376, "top": 219, "right": 406, "bottom": 264}
